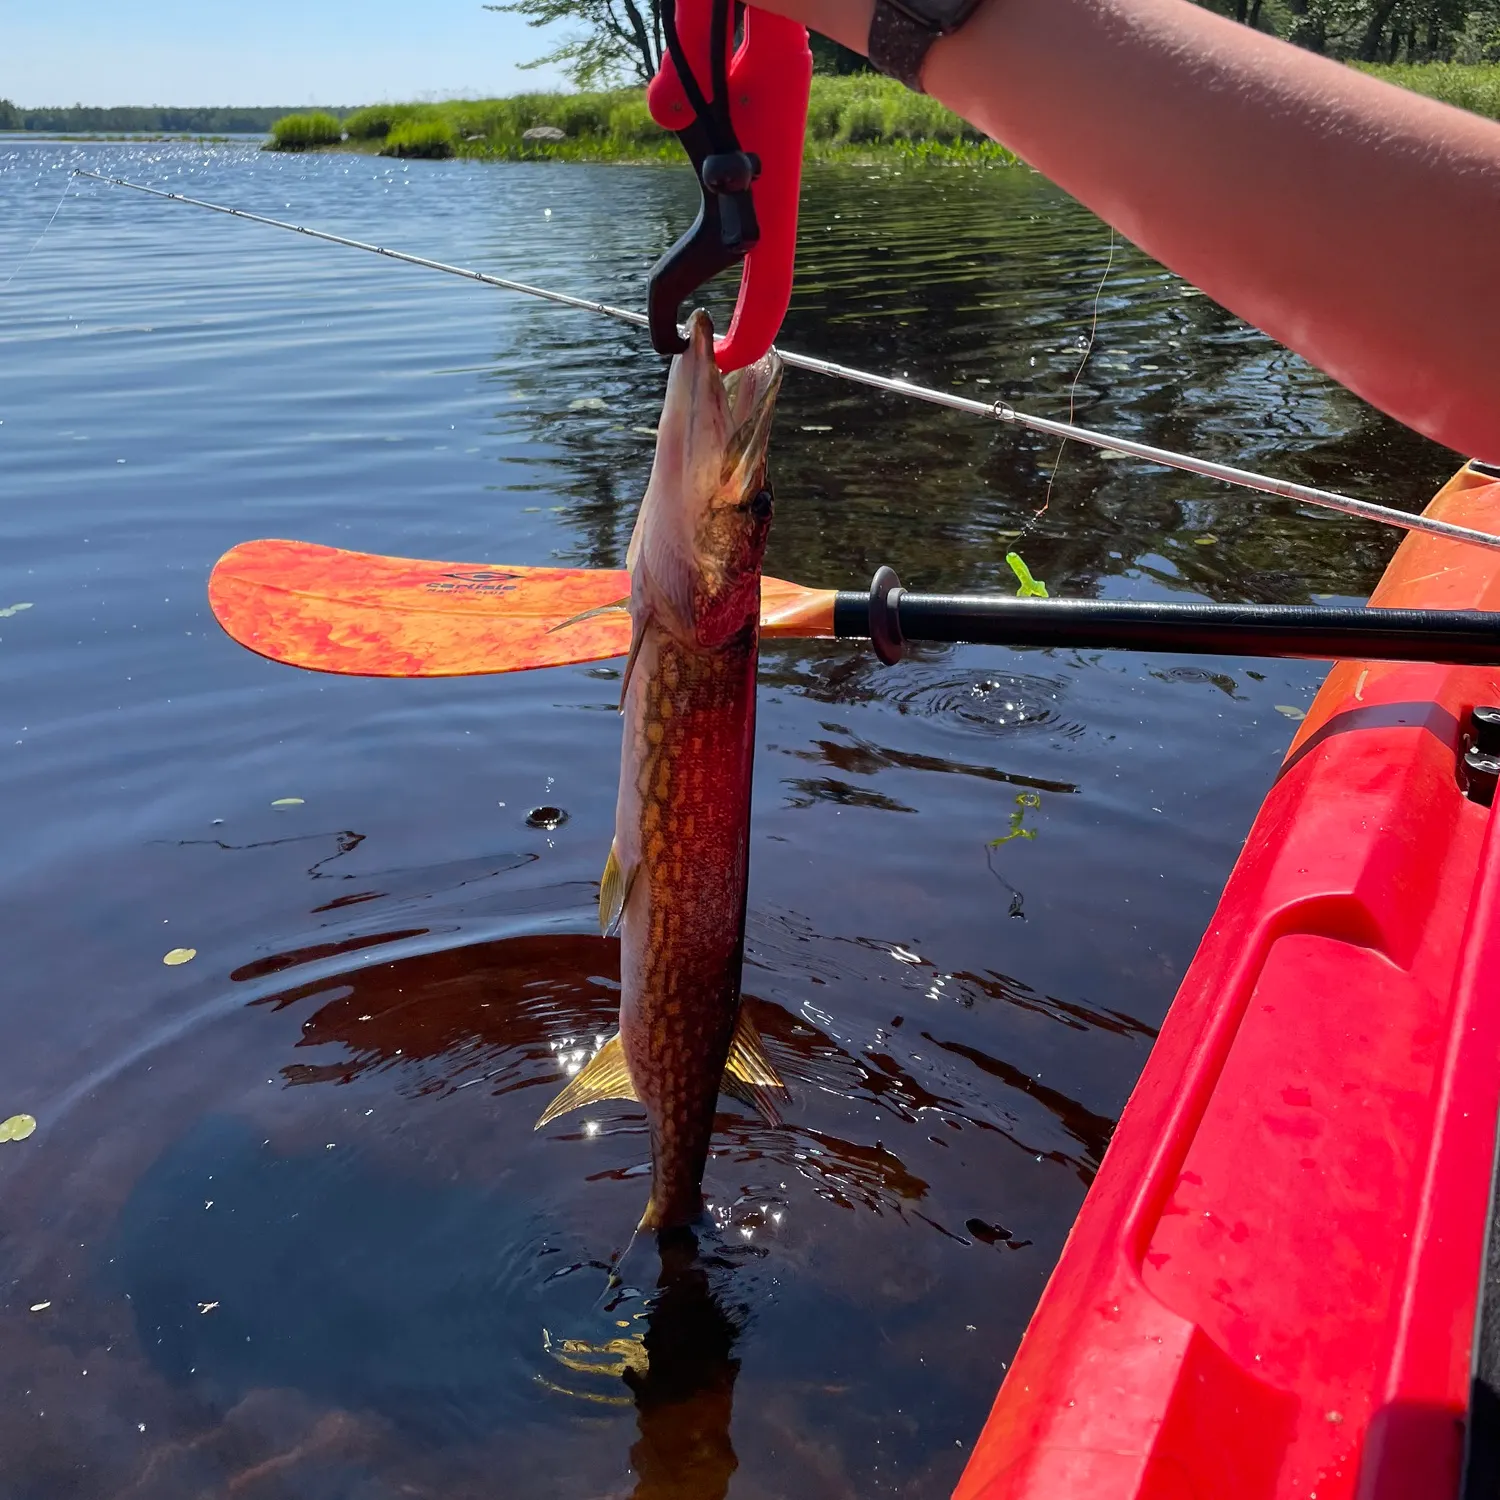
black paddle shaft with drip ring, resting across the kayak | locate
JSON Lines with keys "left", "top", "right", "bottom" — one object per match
{"left": 834, "top": 567, "right": 1500, "bottom": 666}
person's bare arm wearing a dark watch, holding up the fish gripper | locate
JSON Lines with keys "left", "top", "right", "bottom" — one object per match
{"left": 758, "top": 0, "right": 1500, "bottom": 461}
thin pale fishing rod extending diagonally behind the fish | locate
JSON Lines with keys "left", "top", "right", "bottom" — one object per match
{"left": 74, "top": 168, "right": 1500, "bottom": 552}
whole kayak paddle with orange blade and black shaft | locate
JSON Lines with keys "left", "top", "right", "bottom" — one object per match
{"left": 209, "top": 540, "right": 1500, "bottom": 677}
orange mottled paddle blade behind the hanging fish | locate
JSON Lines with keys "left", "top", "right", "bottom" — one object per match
{"left": 209, "top": 540, "right": 834, "bottom": 677}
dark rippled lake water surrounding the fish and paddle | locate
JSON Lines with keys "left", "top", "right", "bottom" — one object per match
{"left": 0, "top": 140, "right": 1457, "bottom": 1500}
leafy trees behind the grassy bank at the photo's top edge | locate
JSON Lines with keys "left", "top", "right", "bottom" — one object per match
{"left": 485, "top": 0, "right": 1500, "bottom": 89}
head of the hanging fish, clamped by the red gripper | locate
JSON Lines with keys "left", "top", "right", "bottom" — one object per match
{"left": 626, "top": 309, "right": 782, "bottom": 648}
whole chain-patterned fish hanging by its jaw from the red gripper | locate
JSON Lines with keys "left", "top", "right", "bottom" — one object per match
{"left": 537, "top": 309, "right": 785, "bottom": 1232}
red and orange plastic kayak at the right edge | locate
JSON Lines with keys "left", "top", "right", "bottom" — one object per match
{"left": 956, "top": 464, "right": 1500, "bottom": 1500}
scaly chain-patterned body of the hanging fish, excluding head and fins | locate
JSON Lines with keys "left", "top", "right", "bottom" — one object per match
{"left": 615, "top": 624, "right": 758, "bottom": 1229}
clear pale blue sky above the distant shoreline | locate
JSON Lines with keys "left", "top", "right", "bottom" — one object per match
{"left": 0, "top": 0, "right": 563, "bottom": 108}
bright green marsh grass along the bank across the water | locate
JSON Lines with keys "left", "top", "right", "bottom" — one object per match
{"left": 270, "top": 63, "right": 1500, "bottom": 164}
